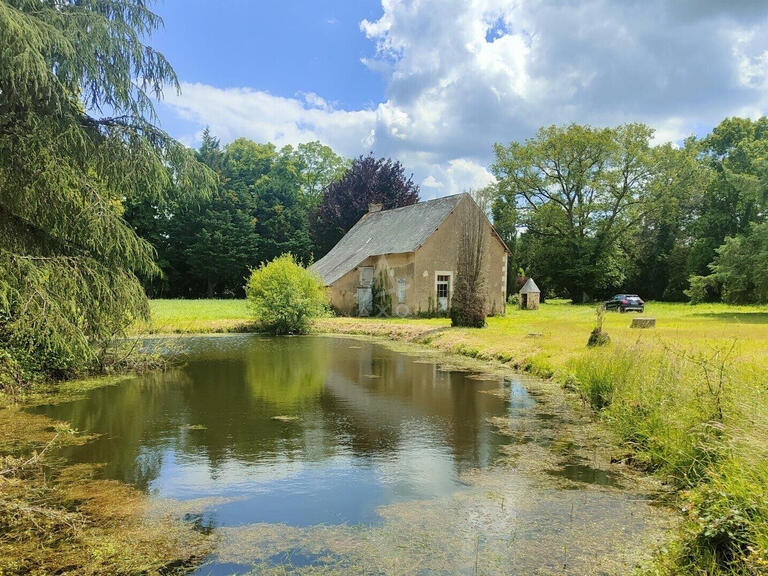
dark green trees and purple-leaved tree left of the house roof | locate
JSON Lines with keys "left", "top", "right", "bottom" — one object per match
{"left": 124, "top": 129, "right": 419, "bottom": 298}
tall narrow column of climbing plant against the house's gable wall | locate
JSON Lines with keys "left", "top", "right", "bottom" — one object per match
{"left": 450, "top": 197, "right": 489, "bottom": 328}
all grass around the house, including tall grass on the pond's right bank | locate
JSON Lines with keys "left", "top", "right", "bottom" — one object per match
{"left": 140, "top": 301, "right": 768, "bottom": 575}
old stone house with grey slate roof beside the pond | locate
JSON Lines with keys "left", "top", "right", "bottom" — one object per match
{"left": 312, "top": 193, "right": 509, "bottom": 316}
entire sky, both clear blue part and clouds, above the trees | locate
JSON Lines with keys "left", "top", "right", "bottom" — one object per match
{"left": 151, "top": 0, "right": 768, "bottom": 198}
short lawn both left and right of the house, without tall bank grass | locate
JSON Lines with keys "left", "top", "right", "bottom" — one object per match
{"left": 142, "top": 300, "right": 768, "bottom": 369}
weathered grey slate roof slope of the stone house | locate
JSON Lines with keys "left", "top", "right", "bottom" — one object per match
{"left": 312, "top": 193, "right": 465, "bottom": 286}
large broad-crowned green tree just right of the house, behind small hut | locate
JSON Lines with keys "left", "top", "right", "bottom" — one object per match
{"left": 493, "top": 124, "right": 659, "bottom": 302}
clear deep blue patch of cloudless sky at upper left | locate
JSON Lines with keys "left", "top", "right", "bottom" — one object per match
{"left": 152, "top": 0, "right": 386, "bottom": 141}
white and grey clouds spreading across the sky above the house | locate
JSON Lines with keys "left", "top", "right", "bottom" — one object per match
{"left": 159, "top": 0, "right": 768, "bottom": 197}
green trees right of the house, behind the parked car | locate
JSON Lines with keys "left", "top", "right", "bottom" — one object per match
{"left": 492, "top": 118, "right": 768, "bottom": 303}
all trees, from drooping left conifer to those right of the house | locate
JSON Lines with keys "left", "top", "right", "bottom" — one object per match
{"left": 0, "top": 0, "right": 768, "bottom": 388}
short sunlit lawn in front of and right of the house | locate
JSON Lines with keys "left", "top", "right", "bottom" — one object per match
{"left": 320, "top": 301, "right": 768, "bottom": 370}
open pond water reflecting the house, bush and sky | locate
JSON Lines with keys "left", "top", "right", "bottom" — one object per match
{"left": 34, "top": 335, "right": 516, "bottom": 526}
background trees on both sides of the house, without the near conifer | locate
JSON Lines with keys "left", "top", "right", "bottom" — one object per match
{"left": 130, "top": 118, "right": 768, "bottom": 303}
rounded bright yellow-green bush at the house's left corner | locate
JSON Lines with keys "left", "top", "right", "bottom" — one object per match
{"left": 245, "top": 254, "right": 327, "bottom": 334}
